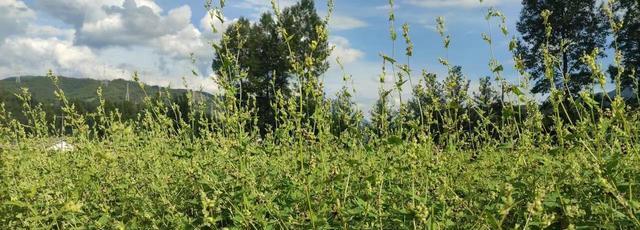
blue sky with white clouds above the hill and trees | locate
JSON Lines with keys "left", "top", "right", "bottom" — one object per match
{"left": 0, "top": 0, "right": 520, "bottom": 111}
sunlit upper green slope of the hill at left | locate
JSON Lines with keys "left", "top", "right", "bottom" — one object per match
{"left": 0, "top": 76, "right": 211, "bottom": 104}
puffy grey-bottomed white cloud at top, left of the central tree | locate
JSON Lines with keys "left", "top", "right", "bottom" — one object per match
{"left": 40, "top": 0, "right": 211, "bottom": 69}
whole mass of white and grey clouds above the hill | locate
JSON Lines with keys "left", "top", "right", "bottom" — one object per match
{"left": 0, "top": 0, "right": 217, "bottom": 92}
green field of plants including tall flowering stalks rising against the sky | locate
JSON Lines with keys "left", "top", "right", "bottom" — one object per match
{"left": 0, "top": 0, "right": 640, "bottom": 229}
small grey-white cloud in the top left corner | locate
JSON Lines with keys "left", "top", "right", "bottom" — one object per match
{"left": 0, "top": 0, "right": 36, "bottom": 43}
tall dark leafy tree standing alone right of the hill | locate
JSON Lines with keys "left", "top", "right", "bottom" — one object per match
{"left": 213, "top": 0, "right": 330, "bottom": 132}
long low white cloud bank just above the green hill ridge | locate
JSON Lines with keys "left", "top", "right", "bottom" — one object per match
{"left": 0, "top": 37, "right": 217, "bottom": 92}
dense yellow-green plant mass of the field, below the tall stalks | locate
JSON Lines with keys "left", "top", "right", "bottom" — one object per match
{"left": 0, "top": 128, "right": 640, "bottom": 229}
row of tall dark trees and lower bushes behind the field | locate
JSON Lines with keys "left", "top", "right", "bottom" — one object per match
{"left": 213, "top": 0, "right": 640, "bottom": 137}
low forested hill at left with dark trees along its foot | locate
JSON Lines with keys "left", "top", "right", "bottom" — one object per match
{"left": 0, "top": 76, "right": 212, "bottom": 122}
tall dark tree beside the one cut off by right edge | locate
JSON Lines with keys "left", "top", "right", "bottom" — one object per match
{"left": 517, "top": 0, "right": 607, "bottom": 93}
